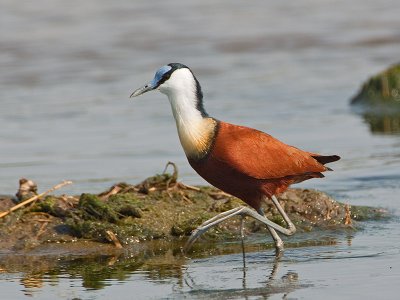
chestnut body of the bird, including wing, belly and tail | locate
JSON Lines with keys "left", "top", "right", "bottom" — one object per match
{"left": 188, "top": 121, "right": 339, "bottom": 210}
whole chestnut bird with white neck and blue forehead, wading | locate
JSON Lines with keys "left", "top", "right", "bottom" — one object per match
{"left": 130, "top": 63, "right": 340, "bottom": 253}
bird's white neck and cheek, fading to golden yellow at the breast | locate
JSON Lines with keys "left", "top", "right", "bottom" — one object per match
{"left": 159, "top": 69, "right": 215, "bottom": 157}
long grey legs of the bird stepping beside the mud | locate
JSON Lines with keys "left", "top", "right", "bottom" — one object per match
{"left": 184, "top": 196, "right": 296, "bottom": 251}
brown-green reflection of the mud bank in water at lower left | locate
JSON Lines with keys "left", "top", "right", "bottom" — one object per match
{"left": 0, "top": 249, "right": 187, "bottom": 293}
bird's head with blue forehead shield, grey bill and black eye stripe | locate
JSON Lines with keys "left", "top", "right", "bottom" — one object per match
{"left": 131, "top": 63, "right": 198, "bottom": 97}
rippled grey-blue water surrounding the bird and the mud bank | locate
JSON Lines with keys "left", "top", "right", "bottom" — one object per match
{"left": 0, "top": 0, "right": 400, "bottom": 299}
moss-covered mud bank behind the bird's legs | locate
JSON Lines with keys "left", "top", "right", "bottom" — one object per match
{"left": 0, "top": 164, "right": 388, "bottom": 254}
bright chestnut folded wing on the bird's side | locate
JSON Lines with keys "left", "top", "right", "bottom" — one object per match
{"left": 212, "top": 122, "right": 327, "bottom": 179}
